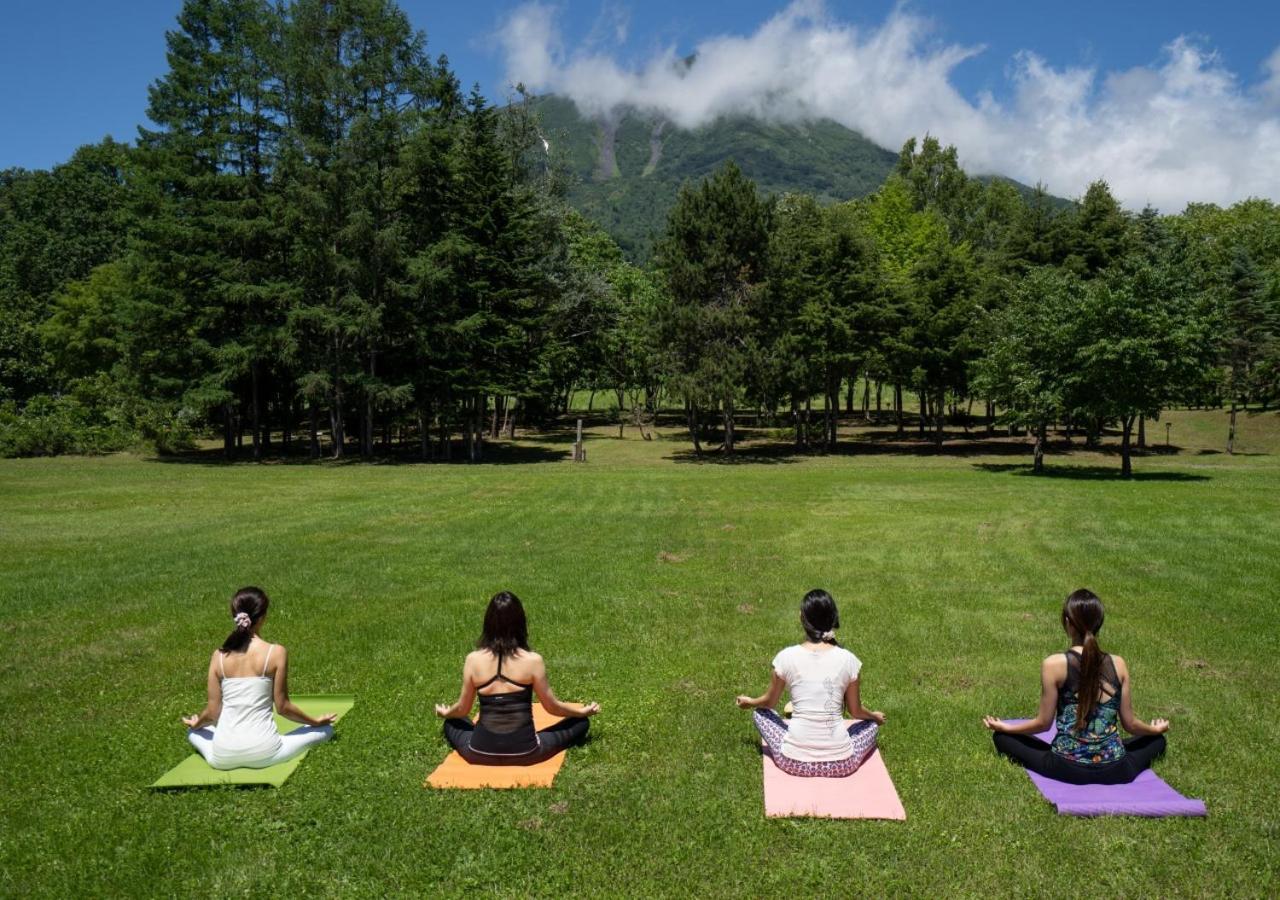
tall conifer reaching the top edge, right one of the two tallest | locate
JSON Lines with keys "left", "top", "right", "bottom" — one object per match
{"left": 282, "top": 0, "right": 436, "bottom": 457}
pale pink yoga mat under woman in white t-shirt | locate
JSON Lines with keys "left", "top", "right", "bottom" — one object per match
{"left": 762, "top": 721, "right": 906, "bottom": 821}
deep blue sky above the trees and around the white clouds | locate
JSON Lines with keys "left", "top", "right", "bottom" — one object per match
{"left": 0, "top": 0, "right": 1280, "bottom": 207}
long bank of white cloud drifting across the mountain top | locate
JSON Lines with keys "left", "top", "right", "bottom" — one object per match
{"left": 498, "top": 0, "right": 1280, "bottom": 211}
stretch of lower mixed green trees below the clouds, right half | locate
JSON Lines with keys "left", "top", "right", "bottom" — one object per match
{"left": 655, "top": 145, "right": 1280, "bottom": 475}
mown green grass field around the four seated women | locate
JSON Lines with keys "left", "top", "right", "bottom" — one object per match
{"left": 0, "top": 412, "right": 1280, "bottom": 896}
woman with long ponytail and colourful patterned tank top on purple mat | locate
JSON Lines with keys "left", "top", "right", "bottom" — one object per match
{"left": 983, "top": 589, "right": 1169, "bottom": 785}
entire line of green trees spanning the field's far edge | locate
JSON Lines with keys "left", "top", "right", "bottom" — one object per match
{"left": 0, "top": 0, "right": 1280, "bottom": 474}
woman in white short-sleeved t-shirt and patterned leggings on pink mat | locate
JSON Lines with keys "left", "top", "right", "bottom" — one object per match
{"left": 737, "top": 590, "right": 884, "bottom": 778}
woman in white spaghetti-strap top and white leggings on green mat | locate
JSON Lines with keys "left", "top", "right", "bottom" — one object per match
{"left": 182, "top": 588, "right": 335, "bottom": 769}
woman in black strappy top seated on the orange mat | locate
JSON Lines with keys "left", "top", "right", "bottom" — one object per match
{"left": 435, "top": 590, "right": 600, "bottom": 766}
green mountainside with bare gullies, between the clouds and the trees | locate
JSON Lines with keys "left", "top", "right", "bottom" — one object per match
{"left": 534, "top": 95, "right": 1068, "bottom": 261}
